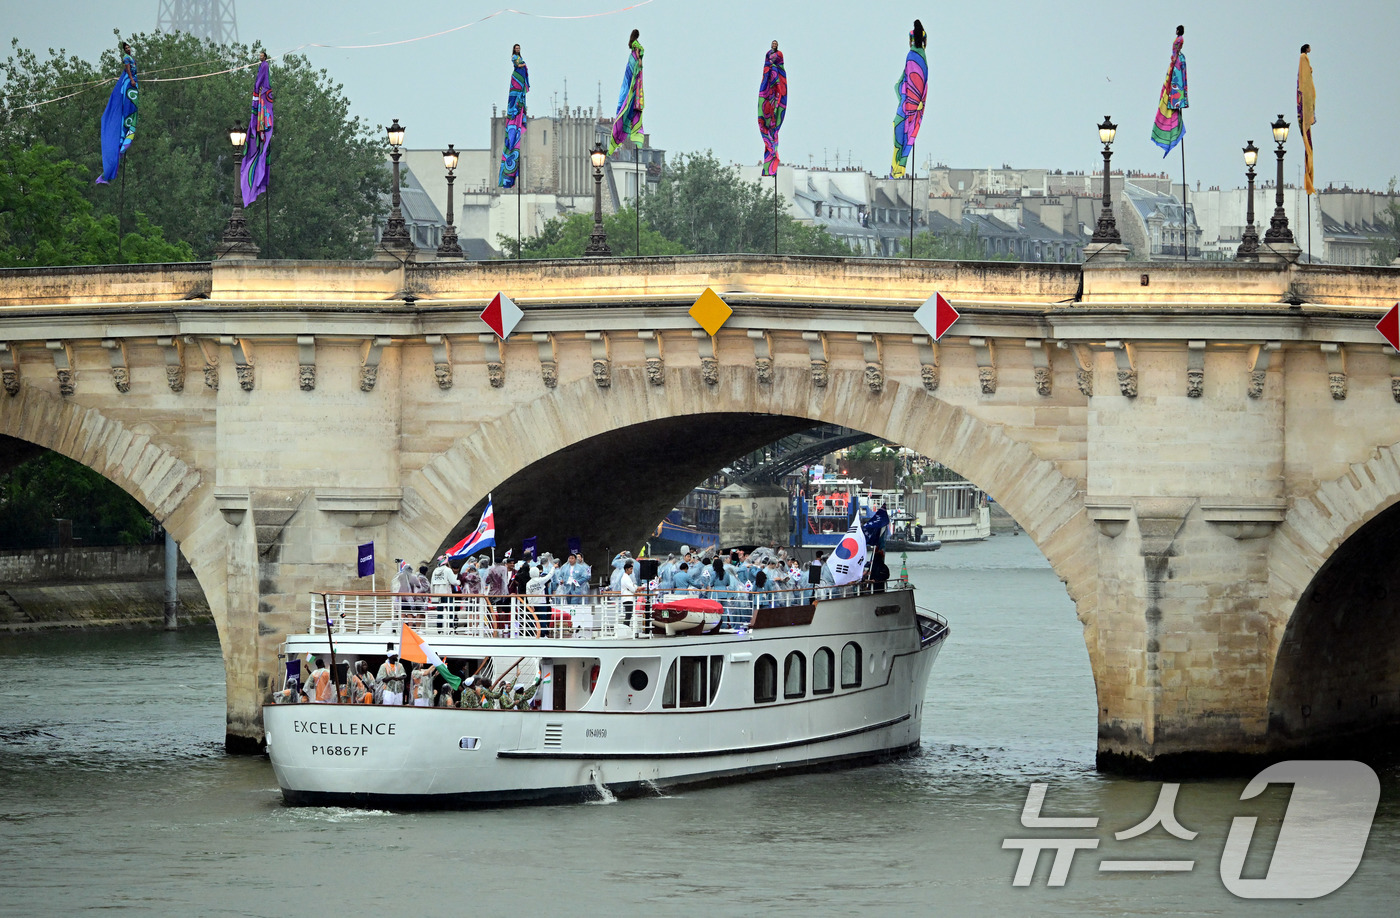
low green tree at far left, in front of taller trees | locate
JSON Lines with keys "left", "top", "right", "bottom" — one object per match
{"left": 0, "top": 144, "right": 195, "bottom": 267}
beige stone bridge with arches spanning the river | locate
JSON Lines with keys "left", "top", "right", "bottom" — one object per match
{"left": 0, "top": 256, "right": 1400, "bottom": 768}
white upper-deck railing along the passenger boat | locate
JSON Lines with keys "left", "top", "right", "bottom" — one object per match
{"left": 309, "top": 579, "right": 910, "bottom": 640}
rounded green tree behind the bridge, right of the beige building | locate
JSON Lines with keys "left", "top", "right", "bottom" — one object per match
{"left": 641, "top": 150, "right": 851, "bottom": 255}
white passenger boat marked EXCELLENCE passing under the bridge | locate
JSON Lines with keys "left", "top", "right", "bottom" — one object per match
{"left": 263, "top": 581, "right": 948, "bottom": 809}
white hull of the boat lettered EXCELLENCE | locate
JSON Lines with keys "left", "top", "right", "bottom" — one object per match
{"left": 263, "top": 641, "right": 941, "bottom": 809}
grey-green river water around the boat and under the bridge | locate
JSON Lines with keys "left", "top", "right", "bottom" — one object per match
{"left": 0, "top": 535, "right": 1400, "bottom": 918}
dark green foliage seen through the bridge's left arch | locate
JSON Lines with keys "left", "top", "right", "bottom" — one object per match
{"left": 0, "top": 452, "right": 153, "bottom": 549}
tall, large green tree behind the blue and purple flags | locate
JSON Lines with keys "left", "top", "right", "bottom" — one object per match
{"left": 0, "top": 32, "right": 389, "bottom": 259}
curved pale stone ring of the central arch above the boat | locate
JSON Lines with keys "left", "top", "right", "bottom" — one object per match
{"left": 391, "top": 367, "right": 1102, "bottom": 684}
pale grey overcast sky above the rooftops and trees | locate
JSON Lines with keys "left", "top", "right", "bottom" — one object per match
{"left": 8, "top": 0, "right": 1400, "bottom": 189}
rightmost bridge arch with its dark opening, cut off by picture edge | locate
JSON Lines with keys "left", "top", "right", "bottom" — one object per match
{"left": 1268, "top": 444, "right": 1400, "bottom": 749}
